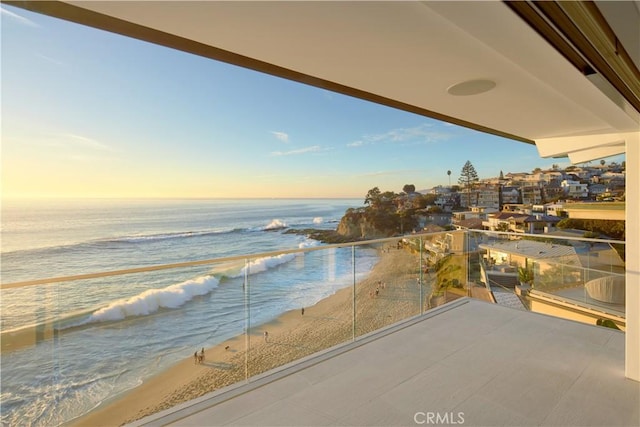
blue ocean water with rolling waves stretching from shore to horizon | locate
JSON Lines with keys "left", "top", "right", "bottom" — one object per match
{"left": 0, "top": 199, "right": 377, "bottom": 426}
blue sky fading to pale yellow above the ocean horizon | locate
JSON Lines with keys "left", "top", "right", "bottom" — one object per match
{"left": 1, "top": 5, "right": 620, "bottom": 198}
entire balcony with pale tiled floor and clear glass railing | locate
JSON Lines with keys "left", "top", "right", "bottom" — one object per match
{"left": 2, "top": 232, "right": 639, "bottom": 425}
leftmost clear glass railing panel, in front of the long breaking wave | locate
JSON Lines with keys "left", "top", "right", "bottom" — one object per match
{"left": 1, "top": 264, "right": 244, "bottom": 425}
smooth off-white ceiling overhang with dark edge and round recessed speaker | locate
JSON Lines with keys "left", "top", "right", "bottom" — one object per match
{"left": 9, "top": 1, "right": 640, "bottom": 160}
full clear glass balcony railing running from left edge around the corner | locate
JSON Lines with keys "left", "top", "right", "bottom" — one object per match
{"left": 1, "top": 231, "right": 624, "bottom": 425}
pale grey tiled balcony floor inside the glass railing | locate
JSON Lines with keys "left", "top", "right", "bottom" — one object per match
{"left": 136, "top": 298, "right": 640, "bottom": 426}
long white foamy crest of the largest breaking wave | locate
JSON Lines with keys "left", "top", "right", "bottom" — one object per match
{"left": 86, "top": 276, "right": 219, "bottom": 323}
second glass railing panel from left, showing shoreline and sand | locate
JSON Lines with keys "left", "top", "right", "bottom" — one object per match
{"left": 248, "top": 246, "right": 358, "bottom": 377}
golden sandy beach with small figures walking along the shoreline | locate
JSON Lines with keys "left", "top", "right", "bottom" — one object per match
{"left": 72, "top": 247, "right": 429, "bottom": 427}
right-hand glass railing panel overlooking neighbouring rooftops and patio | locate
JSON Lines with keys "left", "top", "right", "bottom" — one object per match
{"left": 472, "top": 233, "right": 625, "bottom": 329}
